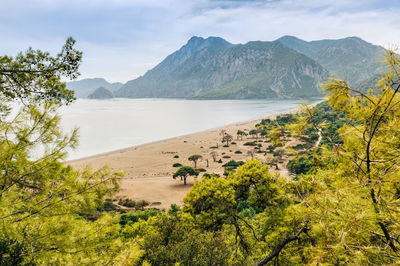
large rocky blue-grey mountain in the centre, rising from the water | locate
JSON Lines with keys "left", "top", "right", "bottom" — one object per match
{"left": 114, "top": 37, "right": 328, "bottom": 99}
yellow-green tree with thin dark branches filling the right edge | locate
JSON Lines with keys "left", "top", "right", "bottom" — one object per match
{"left": 288, "top": 51, "right": 400, "bottom": 265}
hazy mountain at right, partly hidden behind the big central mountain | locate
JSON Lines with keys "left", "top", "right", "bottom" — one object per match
{"left": 277, "top": 36, "right": 384, "bottom": 85}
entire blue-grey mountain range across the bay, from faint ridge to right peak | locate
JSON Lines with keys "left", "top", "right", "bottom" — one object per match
{"left": 67, "top": 36, "right": 384, "bottom": 99}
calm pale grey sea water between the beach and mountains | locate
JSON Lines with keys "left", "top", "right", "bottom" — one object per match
{"left": 61, "top": 99, "right": 318, "bottom": 160}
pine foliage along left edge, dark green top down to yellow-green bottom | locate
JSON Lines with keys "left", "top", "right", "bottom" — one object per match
{"left": 0, "top": 39, "right": 140, "bottom": 264}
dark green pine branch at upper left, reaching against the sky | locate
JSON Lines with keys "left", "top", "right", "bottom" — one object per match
{"left": 0, "top": 38, "right": 82, "bottom": 103}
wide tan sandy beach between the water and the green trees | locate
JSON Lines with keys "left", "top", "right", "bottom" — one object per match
{"left": 68, "top": 104, "right": 306, "bottom": 209}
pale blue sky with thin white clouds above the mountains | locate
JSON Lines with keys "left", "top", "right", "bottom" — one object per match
{"left": 0, "top": 0, "right": 400, "bottom": 82}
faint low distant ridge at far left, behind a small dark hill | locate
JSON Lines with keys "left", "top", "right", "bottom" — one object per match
{"left": 67, "top": 78, "right": 123, "bottom": 98}
